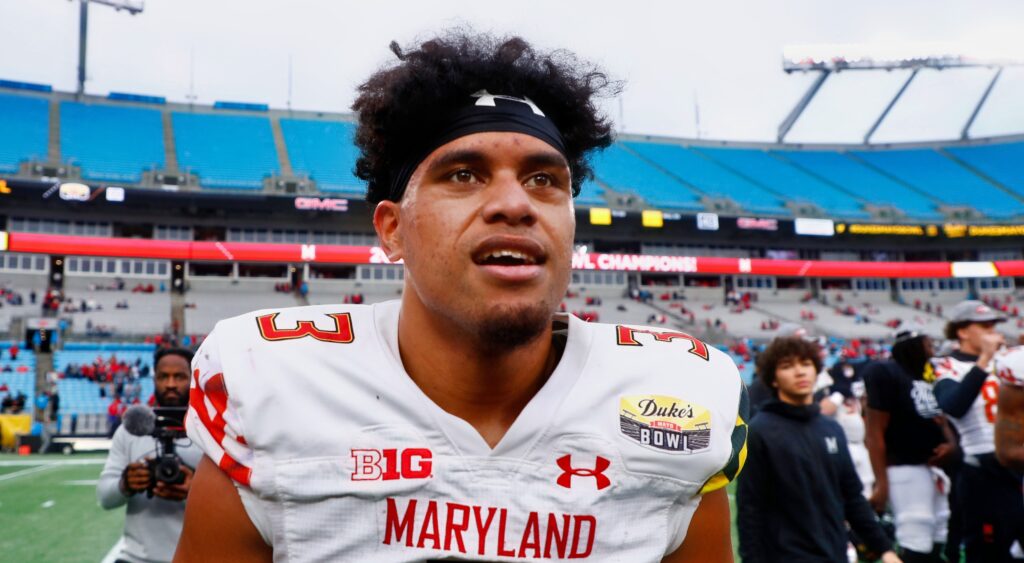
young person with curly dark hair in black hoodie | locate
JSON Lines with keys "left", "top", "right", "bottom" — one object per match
{"left": 736, "top": 337, "right": 900, "bottom": 563}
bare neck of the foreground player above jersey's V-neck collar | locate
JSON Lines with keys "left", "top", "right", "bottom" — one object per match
{"left": 398, "top": 298, "right": 557, "bottom": 447}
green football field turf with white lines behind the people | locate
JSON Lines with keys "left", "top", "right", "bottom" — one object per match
{"left": 0, "top": 454, "right": 738, "bottom": 563}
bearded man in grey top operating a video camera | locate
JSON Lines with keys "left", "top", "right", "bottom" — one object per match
{"left": 96, "top": 349, "right": 203, "bottom": 562}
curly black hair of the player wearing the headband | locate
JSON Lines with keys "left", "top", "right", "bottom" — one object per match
{"left": 352, "top": 30, "right": 622, "bottom": 204}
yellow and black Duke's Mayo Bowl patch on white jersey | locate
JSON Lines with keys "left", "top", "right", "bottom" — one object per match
{"left": 618, "top": 395, "right": 711, "bottom": 453}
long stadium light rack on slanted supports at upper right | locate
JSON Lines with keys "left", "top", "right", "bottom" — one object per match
{"left": 777, "top": 44, "right": 1024, "bottom": 144}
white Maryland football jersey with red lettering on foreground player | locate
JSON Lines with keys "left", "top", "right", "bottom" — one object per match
{"left": 186, "top": 301, "right": 746, "bottom": 563}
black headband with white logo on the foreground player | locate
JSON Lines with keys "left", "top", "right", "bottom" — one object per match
{"left": 387, "top": 90, "right": 565, "bottom": 202}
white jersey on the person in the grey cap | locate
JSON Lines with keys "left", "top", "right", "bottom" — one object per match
{"left": 932, "top": 356, "right": 999, "bottom": 456}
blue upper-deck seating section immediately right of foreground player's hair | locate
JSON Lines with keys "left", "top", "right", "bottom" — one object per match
{"left": 592, "top": 143, "right": 705, "bottom": 211}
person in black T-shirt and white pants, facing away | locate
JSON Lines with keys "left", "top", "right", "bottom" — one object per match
{"left": 864, "top": 323, "right": 956, "bottom": 563}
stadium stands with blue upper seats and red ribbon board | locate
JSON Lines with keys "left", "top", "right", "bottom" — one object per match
{"left": 0, "top": 81, "right": 1024, "bottom": 560}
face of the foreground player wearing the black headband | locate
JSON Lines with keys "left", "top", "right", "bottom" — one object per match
{"left": 374, "top": 133, "right": 575, "bottom": 349}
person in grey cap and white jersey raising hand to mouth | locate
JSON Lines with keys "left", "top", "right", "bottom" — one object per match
{"left": 932, "top": 300, "right": 1024, "bottom": 563}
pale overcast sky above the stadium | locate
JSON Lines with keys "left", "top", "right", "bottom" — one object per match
{"left": 0, "top": 0, "right": 1024, "bottom": 141}
